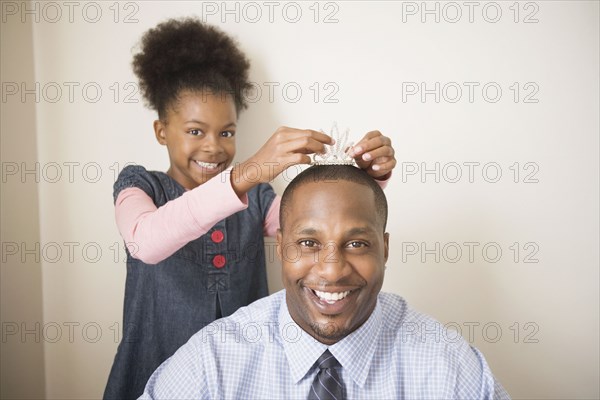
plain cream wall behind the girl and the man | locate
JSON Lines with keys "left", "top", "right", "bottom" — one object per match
{"left": 1, "top": 1, "right": 600, "bottom": 399}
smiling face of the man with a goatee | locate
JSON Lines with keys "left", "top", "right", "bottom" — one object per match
{"left": 277, "top": 180, "right": 388, "bottom": 344}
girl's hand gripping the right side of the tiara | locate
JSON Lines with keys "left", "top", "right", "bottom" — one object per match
{"left": 348, "top": 131, "right": 396, "bottom": 180}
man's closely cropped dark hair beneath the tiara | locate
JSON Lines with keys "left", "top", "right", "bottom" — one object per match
{"left": 279, "top": 165, "right": 388, "bottom": 231}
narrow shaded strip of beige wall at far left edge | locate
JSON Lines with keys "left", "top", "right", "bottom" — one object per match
{"left": 0, "top": 7, "right": 45, "bottom": 399}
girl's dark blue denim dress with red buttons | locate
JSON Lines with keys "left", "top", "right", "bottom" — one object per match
{"left": 104, "top": 166, "right": 275, "bottom": 399}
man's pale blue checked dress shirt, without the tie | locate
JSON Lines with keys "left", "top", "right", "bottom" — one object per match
{"left": 140, "top": 290, "right": 509, "bottom": 400}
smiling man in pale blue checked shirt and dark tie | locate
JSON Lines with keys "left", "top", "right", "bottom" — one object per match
{"left": 142, "top": 166, "right": 508, "bottom": 399}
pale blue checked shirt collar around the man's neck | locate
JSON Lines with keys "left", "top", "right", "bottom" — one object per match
{"left": 278, "top": 290, "right": 382, "bottom": 387}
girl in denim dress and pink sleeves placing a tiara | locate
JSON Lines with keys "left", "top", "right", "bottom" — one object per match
{"left": 104, "top": 19, "right": 396, "bottom": 399}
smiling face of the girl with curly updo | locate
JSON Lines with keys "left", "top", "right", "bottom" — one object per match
{"left": 154, "top": 92, "right": 237, "bottom": 189}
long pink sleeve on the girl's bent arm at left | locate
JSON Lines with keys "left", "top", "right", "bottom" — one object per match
{"left": 115, "top": 172, "right": 248, "bottom": 264}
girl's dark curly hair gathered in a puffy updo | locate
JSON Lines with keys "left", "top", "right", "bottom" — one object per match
{"left": 132, "top": 18, "right": 252, "bottom": 119}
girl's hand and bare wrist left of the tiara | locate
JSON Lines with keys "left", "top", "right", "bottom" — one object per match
{"left": 231, "top": 126, "right": 333, "bottom": 196}
